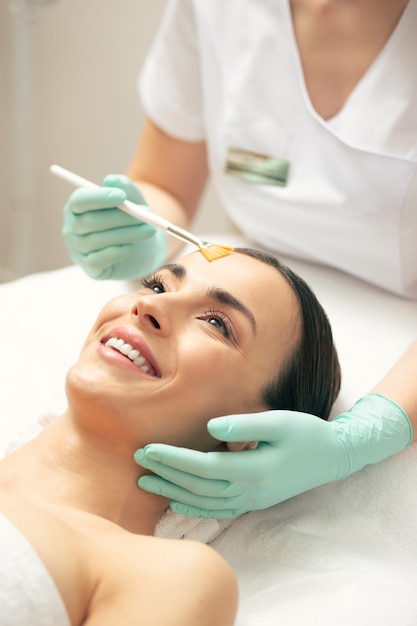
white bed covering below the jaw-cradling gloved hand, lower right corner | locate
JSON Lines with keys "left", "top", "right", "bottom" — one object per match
{"left": 212, "top": 444, "right": 417, "bottom": 626}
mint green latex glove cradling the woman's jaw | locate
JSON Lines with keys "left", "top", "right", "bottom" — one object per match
{"left": 134, "top": 394, "right": 412, "bottom": 519}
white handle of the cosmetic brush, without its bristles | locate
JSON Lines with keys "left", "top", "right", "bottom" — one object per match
{"left": 49, "top": 165, "right": 204, "bottom": 248}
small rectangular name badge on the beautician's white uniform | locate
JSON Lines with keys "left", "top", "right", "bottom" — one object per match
{"left": 225, "top": 148, "right": 290, "bottom": 187}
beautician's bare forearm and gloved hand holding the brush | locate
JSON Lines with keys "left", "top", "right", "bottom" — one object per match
{"left": 62, "top": 120, "right": 208, "bottom": 279}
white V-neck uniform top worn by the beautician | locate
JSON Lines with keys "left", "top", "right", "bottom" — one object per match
{"left": 139, "top": 0, "right": 417, "bottom": 298}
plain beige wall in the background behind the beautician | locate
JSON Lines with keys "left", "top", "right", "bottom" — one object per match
{"left": 0, "top": 0, "right": 229, "bottom": 280}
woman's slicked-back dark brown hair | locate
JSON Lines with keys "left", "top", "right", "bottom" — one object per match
{"left": 235, "top": 248, "right": 341, "bottom": 419}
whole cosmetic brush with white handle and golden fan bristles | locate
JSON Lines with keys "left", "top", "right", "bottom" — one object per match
{"left": 49, "top": 165, "right": 233, "bottom": 261}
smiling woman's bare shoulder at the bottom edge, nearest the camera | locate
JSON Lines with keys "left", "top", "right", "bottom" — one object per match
{"left": 85, "top": 533, "right": 238, "bottom": 626}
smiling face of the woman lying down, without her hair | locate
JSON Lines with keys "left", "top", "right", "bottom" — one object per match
{"left": 67, "top": 252, "right": 300, "bottom": 450}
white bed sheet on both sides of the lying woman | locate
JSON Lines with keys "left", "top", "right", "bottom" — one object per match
{"left": 0, "top": 235, "right": 417, "bottom": 626}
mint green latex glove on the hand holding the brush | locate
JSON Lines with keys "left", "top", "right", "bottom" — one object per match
{"left": 62, "top": 175, "right": 168, "bottom": 280}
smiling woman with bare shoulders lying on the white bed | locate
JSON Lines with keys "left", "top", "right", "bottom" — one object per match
{"left": 0, "top": 249, "right": 340, "bottom": 626}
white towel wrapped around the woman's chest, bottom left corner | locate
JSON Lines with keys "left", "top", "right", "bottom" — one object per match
{"left": 0, "top": 513, "right": 71, "bottom": 626}
